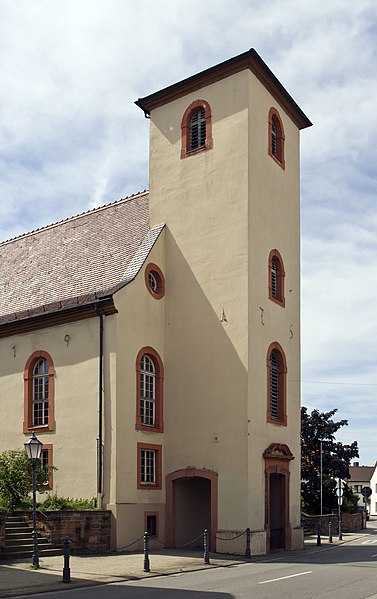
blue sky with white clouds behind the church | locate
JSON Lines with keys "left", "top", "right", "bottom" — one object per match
{"left": 0, "top": 0, "right": 377, "bottom": 465}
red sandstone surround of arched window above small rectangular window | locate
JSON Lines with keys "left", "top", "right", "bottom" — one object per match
{"left": 135, "top": 346, "right": 164, "bottom": 433}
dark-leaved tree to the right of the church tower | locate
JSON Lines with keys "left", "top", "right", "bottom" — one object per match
{"left": 301, "top": 407, "right": 359, "bottom": 514}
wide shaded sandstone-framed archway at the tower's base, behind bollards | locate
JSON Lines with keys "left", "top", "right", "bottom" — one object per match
{"left": 166, "top": 468, "right": 217, "bottom": 551}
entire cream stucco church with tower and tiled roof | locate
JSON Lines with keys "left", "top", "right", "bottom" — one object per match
{"left": 0, "top": 50, "right": 311, "bottom": 553}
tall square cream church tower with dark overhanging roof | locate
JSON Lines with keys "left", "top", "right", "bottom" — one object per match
{"left": 137, "top": 50, "right": 311, "bottom": 553}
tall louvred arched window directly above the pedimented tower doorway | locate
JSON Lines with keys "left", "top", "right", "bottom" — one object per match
{"left": 267, "top": 342, "right": 287, "bottom": 425}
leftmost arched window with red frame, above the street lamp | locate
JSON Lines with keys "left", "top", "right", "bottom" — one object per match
{"left": 23, "top": 350, "right": 55, "bottom": 433}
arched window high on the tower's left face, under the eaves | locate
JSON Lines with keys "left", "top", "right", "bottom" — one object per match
{"left": 181, "top": 100, "right": 212, "bottom": 158}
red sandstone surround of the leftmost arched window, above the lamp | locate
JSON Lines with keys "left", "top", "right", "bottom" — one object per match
{"left": 23, "top": 350, "right": 55, "bottom": 433}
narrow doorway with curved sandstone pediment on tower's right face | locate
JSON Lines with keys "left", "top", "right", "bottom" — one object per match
{"left": 263, "top": 443, "right": 294, "bottom": 552}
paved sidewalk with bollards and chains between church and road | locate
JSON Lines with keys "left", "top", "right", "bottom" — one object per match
{"left": 0, "top": 529, "right": 368, "bottom": 597}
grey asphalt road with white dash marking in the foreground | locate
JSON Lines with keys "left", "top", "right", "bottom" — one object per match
{"left": 13, "top": 522, "right": 377, "bottom": 599}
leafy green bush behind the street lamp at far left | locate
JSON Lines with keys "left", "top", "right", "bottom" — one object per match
{"left": 0, "top": 449, "right": 48, "bottom": 511}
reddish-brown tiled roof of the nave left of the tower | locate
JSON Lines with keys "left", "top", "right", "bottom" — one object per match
{"left": 0, "top": 192, "right": 162, "bottom": 324}
